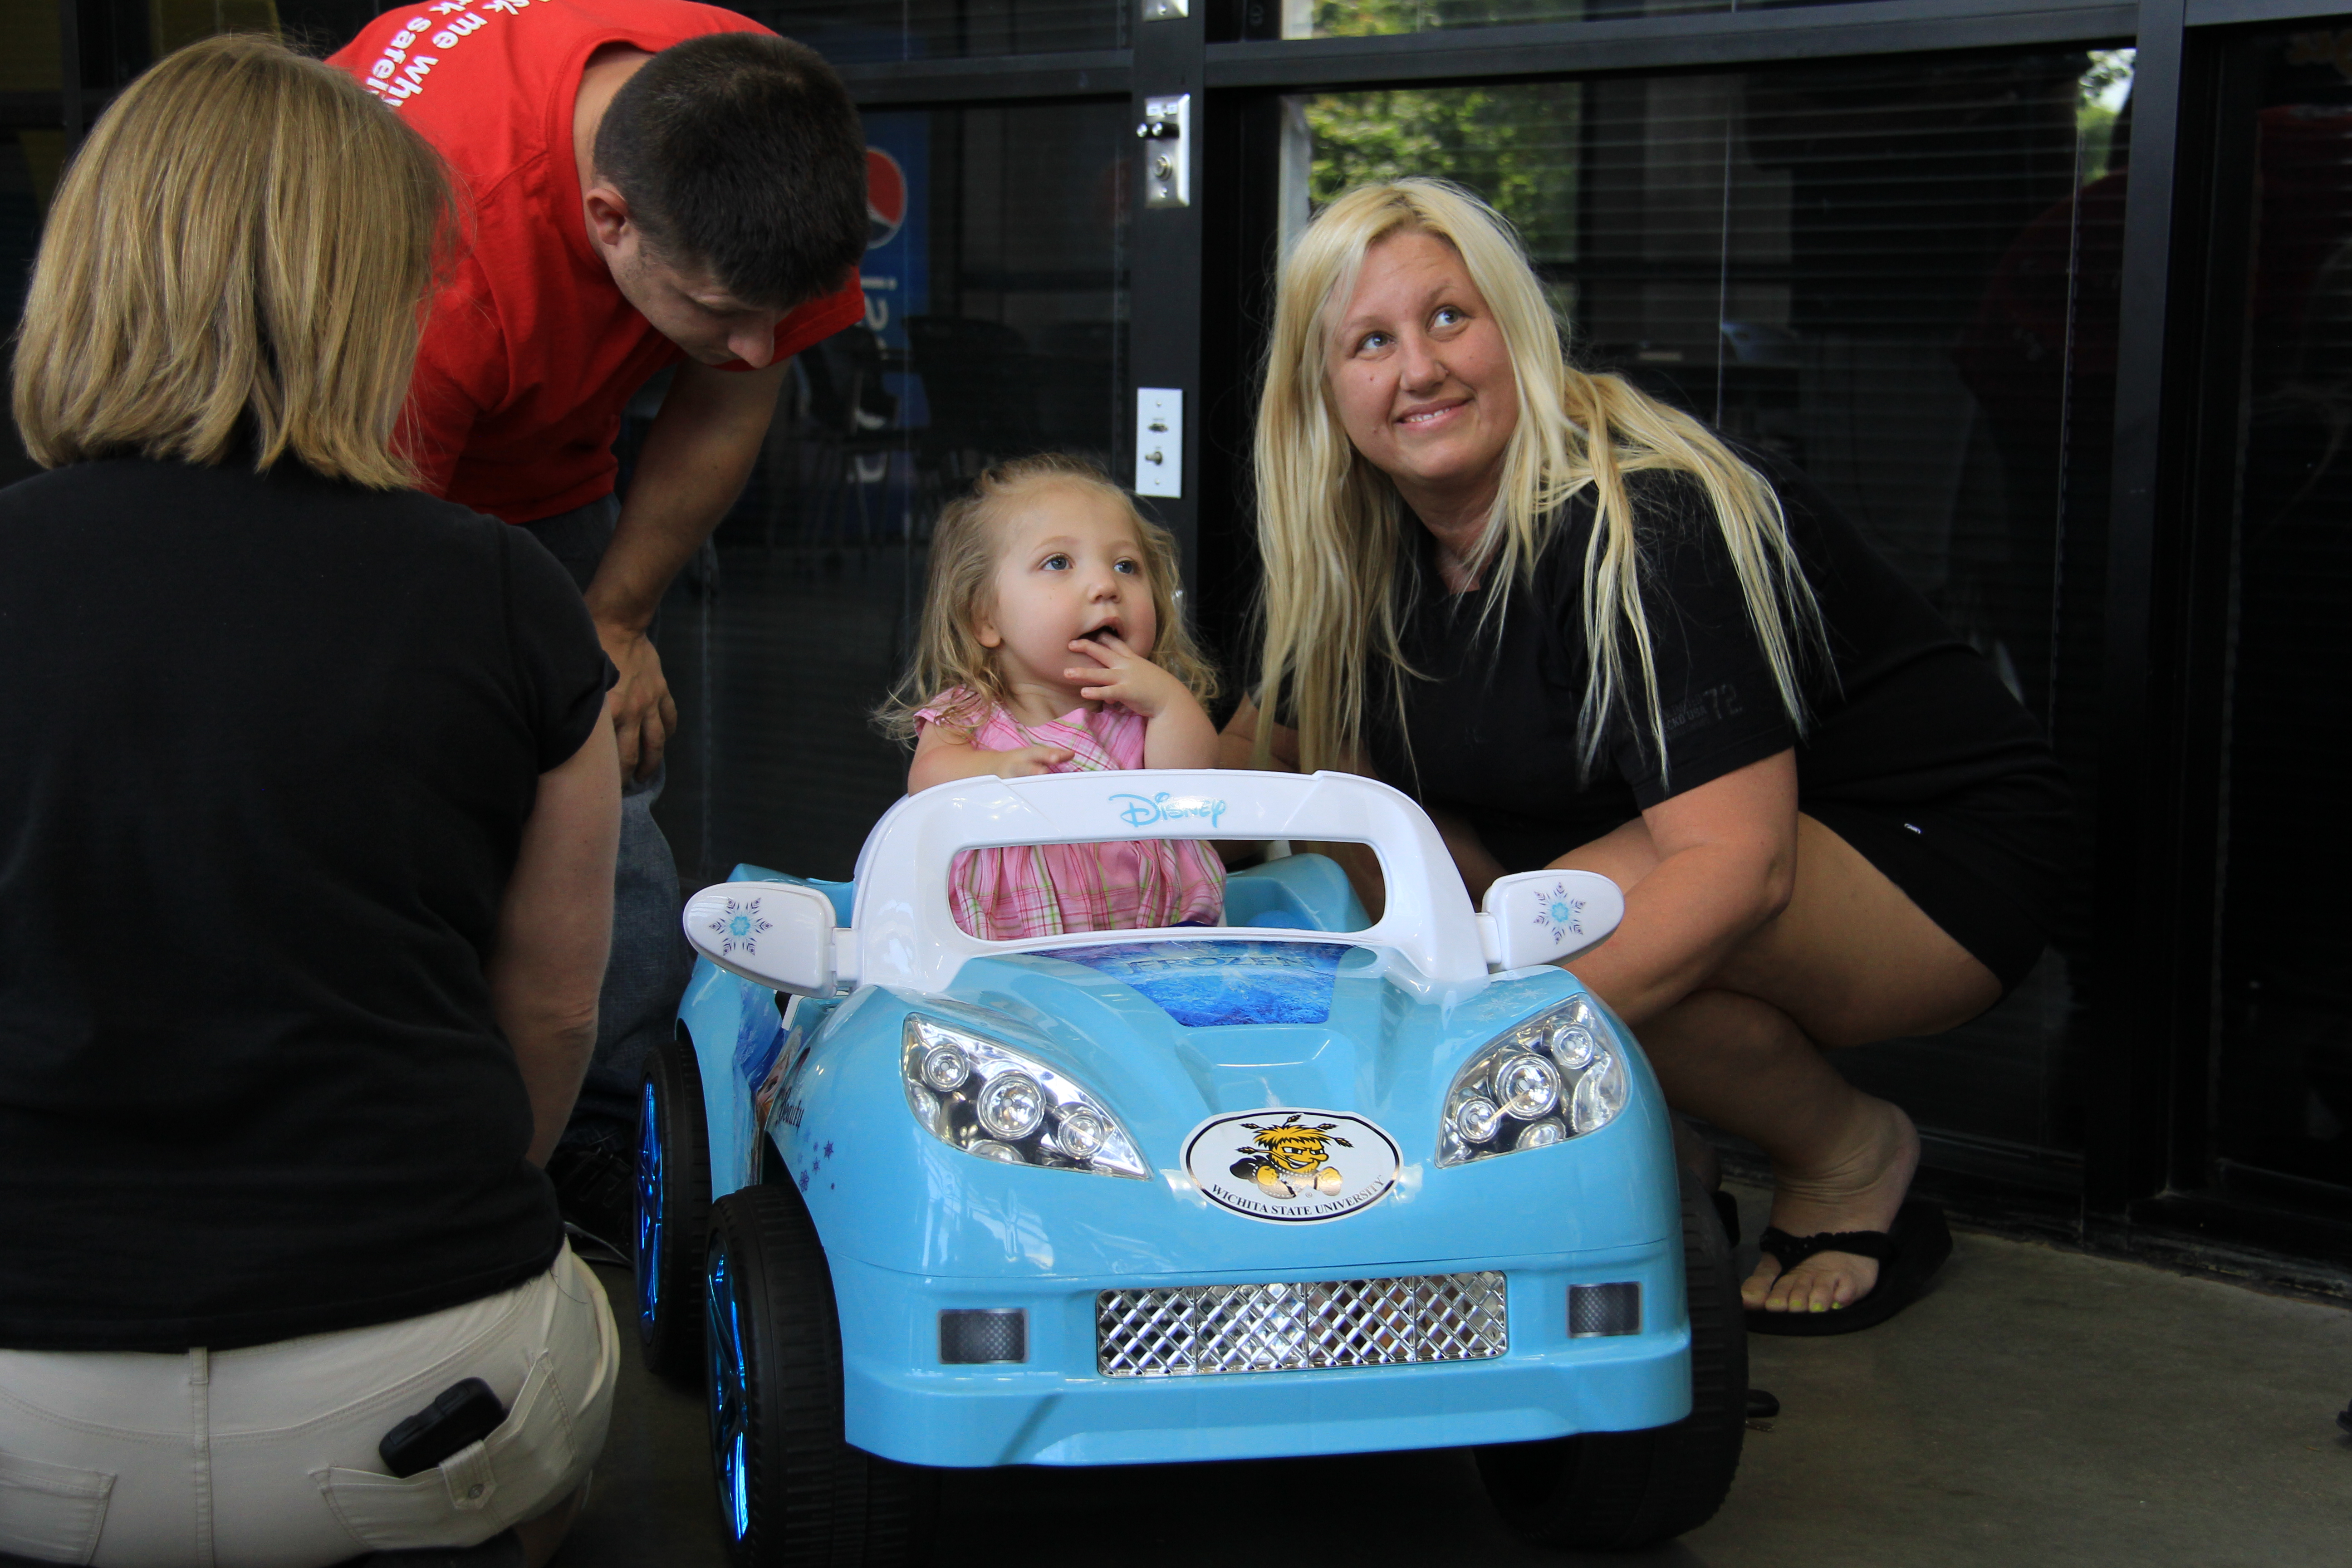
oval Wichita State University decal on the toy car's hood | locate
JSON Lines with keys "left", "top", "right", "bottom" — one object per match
{"left": 1183, "top": 1107, "right": 1399, "bottom": 1225}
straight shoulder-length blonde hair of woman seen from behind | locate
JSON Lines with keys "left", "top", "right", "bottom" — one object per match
{"left": 14, "top": 35, "right": 451, "bottom": 489}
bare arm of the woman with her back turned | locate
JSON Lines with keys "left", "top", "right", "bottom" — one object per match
{"left": 489, "top": 720, "right": 621, "bottom": 1166}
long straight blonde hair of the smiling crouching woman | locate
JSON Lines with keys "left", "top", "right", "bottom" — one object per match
{"left": 1256, "top": 179, "right": 1825, "bottom": 771}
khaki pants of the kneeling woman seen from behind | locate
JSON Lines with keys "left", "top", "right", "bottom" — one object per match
{"left": 0, "top": 1246, "right": 621, "bottom": 1568}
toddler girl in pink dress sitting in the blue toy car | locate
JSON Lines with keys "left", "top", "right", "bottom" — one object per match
{"left": 875, "top": 456, "right": 1225, "bottom": 941}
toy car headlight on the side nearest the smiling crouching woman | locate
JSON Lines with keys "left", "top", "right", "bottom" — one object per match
{"left": 1437, "top": 997, "right": 1630, "bottom": 1166}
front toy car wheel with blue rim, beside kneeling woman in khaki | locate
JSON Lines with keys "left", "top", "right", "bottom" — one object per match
{"left": 703, "top": 1185, "right": 936, "bottom": 1568}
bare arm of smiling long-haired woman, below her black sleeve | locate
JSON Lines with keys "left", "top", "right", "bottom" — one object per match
{"left": 1552, "top": 750, "right": 1797, "bottom": 1029}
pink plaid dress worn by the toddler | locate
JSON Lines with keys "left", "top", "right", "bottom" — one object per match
{"left": 915, "top": 686, "right": 1225, "bottom": 943}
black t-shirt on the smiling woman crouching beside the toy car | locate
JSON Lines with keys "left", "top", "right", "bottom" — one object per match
{"left": 1369, "top": 463, "right": 2065, "bottom": 877}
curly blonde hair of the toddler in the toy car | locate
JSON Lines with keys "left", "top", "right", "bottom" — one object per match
{"left": 872, "top": 451, "right": 1216, "bottom": 740}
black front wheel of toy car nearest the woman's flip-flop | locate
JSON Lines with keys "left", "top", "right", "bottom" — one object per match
{"left": 1477, "top": 1178, "right": 1748, "bottom": 1552}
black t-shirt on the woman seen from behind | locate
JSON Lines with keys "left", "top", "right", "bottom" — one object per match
{"left": 0, "top": 461, "right": 609, "bottom": 1352}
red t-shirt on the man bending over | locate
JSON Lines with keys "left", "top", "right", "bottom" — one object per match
{"left": 327, "top": 0, "right": 866, "bottom": 522}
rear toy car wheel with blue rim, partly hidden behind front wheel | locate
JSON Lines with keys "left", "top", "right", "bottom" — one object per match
{"left": 632, "top": 1039, "right": 710, "bottom": 1382}
